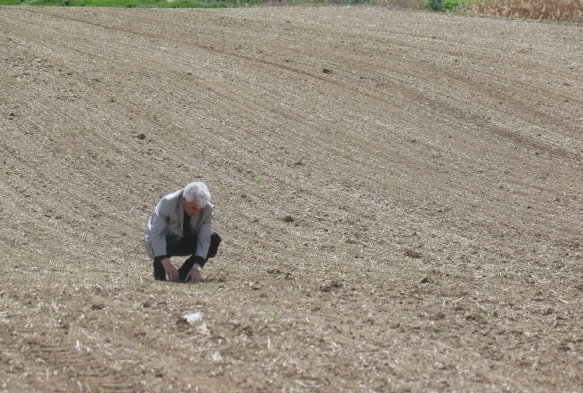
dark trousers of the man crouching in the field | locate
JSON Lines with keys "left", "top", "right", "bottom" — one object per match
{"left": 154, "top": 232, "right": 221, "bottom": 281}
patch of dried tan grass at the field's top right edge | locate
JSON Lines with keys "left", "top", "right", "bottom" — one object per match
{"left": 466, "top": 0, "right": 583, "bottom": 23}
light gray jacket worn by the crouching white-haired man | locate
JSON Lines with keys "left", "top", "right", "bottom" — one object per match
{"left": 144, "top": 189, "right": 213, "bottom": 259}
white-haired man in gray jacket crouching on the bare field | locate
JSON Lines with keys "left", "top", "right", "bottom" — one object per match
{"left": 144, "top": 182, "right": 221, "bottom": 283}
